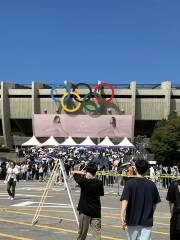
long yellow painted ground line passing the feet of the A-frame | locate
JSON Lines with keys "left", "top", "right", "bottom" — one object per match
{"left": 0, "top": 219, "right": 125, "bottom": 240}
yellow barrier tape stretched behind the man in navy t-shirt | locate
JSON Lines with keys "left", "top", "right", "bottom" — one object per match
{"left": 96, "top": 172, "right": 180, "bottom": 179}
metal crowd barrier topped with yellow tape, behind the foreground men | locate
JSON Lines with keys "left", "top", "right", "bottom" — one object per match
{"left": 96, "top": 172, "right": 180, "bottom": 195}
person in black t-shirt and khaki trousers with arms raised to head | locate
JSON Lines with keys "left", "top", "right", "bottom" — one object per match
{"left": 72, "top": 163, "right": 104, "bottom": 240}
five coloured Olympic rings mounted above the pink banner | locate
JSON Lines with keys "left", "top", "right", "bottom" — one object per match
{"left": 51, "top": 82, "right": 115, "bottom": 113}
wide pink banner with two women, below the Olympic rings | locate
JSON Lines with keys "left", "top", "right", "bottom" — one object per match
{"left": 34, "top": 114, "right": 133, "bottom": 138}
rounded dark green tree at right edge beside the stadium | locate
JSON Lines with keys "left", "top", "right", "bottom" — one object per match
{"left": 150, "top": 116, "right": 180, "bottom": 165}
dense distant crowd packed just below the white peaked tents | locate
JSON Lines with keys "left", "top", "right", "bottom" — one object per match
{"left": 12, "top": 147, "right": 133, "bottom": 181}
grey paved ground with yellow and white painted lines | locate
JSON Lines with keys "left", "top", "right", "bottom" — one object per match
{"left": 0, "top": 181, "right": 170, "bottom": 240}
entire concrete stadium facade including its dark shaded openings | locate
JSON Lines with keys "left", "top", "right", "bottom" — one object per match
{"left": 0, "top": 81, "right": 180, "bottom": 147}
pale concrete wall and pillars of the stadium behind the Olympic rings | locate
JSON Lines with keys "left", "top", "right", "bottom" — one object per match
{"left": 0, "top": 81, "right": 180, "bottom": 147}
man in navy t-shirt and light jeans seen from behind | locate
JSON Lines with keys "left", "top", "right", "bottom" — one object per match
{"left": 120, "top": 159, "right": 161, "bottom": 240}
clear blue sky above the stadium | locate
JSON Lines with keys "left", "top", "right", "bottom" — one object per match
{"left": 0, "top": 0, "right": 180, "bottom": 84}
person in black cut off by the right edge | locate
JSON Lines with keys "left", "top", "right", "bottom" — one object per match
{"left": 166, "top": 163, "right": 180, "bottom": 240}
